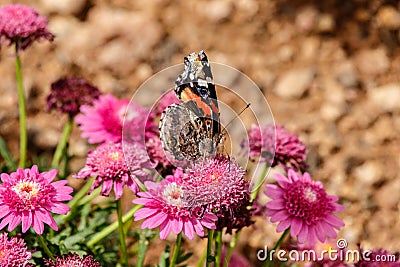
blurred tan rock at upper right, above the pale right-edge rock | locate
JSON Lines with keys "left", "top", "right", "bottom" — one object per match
{"left": 355, "top": 47, "right": 390, "bottom": 76}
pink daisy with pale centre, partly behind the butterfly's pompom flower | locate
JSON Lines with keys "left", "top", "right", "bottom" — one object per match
{"left": 133, "top": 168, "right": 217, "bottom": 239}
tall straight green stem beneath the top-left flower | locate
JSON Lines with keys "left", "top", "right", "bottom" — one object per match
{"left": 15, "top": 46, "right": 28, "bottom": 168}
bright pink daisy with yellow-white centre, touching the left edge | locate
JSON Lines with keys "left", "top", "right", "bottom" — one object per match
{"left": 0, "top": 165, "right": 73, "bottom": 235}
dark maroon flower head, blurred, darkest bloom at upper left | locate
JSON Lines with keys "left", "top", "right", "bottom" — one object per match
{"left": 46, "top": 77, "right": 101, "bottom": 117}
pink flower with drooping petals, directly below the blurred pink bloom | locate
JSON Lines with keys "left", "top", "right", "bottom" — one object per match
{"left": 72, "top": 143, "right": 151, "bottom": 199}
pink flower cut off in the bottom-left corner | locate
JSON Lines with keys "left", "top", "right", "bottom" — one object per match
{"left": 0, "top": 233, "right": 33, "bottom": 267}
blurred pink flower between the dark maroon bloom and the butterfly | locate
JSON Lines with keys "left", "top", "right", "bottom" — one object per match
{"left": 75, "top": 94, "right": 148, "bottom": 144}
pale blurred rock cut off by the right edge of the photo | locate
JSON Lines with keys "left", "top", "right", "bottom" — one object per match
{"left": 368, "top": 83, "right": 400, "bottom": 112}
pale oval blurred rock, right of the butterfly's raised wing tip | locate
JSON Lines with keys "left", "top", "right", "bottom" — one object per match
{"left": 274, "top": 67, "right": 315, "bottom": 99}
